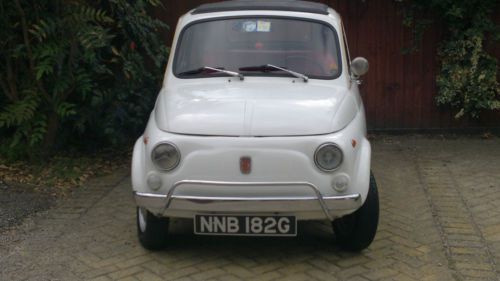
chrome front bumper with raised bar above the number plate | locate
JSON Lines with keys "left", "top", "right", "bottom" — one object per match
{"left": 134, "top": 180, "right": 362, "bottom": 221}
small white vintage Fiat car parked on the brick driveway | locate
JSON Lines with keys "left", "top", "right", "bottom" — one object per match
{"left": 132, "top": 0, "right": 379, "bottom": 251}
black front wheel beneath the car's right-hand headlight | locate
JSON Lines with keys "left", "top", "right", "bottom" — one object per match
{"left": 332, "top": 174, "right": 379, "bottom": 252}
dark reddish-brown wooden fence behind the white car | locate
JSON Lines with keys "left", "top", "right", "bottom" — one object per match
{"left": 155, "top": 0, "right": 500, "bottom": 130}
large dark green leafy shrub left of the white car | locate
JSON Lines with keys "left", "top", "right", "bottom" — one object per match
{"left": 0, "top": 0, "right": 168, "bottom": 158}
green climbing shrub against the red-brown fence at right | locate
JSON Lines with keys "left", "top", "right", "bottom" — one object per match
{"left": 404, "top": 0, "right": 500, "bottom": 118}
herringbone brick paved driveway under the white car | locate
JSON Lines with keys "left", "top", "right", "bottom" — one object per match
{"left": 0, "top": 136, "right": 500, "bottom": 281}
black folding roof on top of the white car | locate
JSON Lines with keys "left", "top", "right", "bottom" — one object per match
{"left": 192, "top": 0, "right": 328, "bottom": 15}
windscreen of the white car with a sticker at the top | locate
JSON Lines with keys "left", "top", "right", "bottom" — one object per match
{"left": 174, "top": 17, "right": 341, "bottom": 79}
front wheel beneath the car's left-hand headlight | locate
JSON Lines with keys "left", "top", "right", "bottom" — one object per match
{"left": 137, "top": 207, "right": 169, "bottom": 250}
